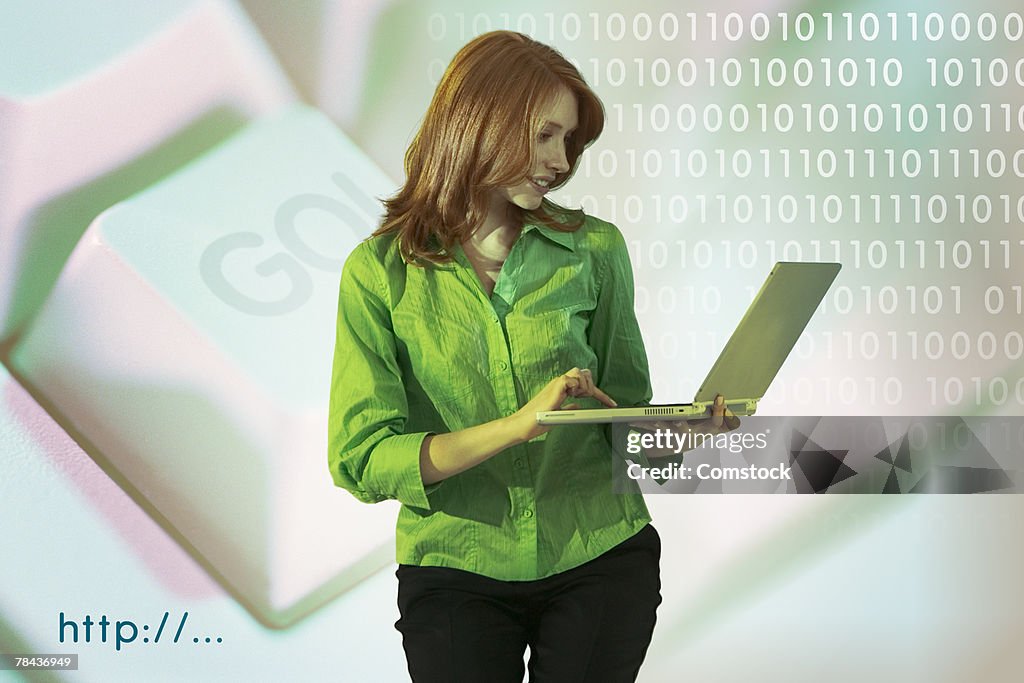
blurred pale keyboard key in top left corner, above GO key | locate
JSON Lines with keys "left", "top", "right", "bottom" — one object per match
{"left": 0, "top": 0, "right": 295, "bottom": 339}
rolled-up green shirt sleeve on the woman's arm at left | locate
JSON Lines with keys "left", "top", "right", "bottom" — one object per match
{"left": 328, "top": 243, "right": 438, "bottom": 509}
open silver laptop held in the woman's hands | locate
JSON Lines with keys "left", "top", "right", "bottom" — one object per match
{"left": 537, "top": 261, "right": 842, "bottom": 425}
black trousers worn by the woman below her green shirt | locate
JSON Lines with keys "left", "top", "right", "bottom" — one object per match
{"left": 394, "top": 524, "right": 662, "bottom": 683}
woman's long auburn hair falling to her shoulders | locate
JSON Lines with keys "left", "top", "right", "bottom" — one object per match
{"left": 374, "top": 31, "right": 604, "bottom": 265}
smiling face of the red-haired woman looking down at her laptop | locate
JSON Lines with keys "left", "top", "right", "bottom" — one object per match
{"left": 493, "top": 86, "right": 579, "bottom": 211}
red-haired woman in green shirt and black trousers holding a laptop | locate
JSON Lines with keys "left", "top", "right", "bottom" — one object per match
{"left": 329, "top": 32, "right": 729, "bottom": 682}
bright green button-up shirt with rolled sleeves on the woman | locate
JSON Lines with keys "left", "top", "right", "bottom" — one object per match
{"left": 328, "top": 210, "right": 651, "bottom": 581}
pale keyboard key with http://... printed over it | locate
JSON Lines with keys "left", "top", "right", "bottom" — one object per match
{"left": 0, "top": 366, "right": 408, "bottom": 681}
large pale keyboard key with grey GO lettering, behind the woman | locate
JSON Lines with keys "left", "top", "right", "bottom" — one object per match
{"left": 12, "top": 106, "right": 397, "bottom": 623}
